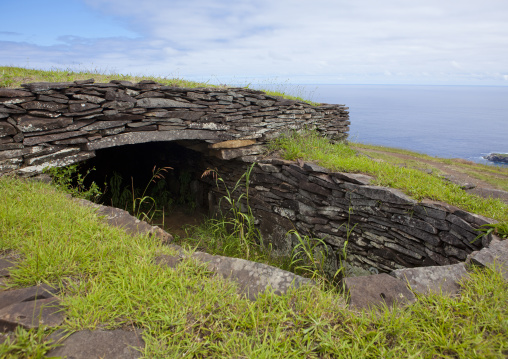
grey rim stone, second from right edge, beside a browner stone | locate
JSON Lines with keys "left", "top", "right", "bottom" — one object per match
{"left": 391, "top": 263, "right": 468, "bottom": 295}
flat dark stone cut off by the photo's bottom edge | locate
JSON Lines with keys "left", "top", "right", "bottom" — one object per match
{"left": 47, "top": 329, "right": 145, "bottom": 359}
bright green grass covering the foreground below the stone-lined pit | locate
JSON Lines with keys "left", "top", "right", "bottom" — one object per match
{"left": 0, "top": 177, "right": 508, "bottom": 358}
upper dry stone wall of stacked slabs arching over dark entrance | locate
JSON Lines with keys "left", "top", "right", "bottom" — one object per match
{"left": 0, "top": 80, "right": 349, "bottom": 175}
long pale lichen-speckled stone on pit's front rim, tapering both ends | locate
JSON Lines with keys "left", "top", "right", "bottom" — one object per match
{"left": 192, "top": 252, "right": 313, "bottom": 300}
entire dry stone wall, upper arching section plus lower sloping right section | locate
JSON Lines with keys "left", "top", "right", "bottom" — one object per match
{"left": 0, "top": 80, "right": 496, "bottom": 274}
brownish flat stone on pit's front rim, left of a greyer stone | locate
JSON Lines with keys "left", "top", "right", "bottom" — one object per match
{"left": 343, "top": 273, "right": 416, "bottom": 309}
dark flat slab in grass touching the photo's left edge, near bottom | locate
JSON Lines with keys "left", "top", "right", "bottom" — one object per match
{"left": 0, "top": 298, "right": 64, "bottom": 332}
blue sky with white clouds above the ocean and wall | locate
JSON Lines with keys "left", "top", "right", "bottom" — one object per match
{"left": 0, "top": 0, "right": 508, "bottom": 86}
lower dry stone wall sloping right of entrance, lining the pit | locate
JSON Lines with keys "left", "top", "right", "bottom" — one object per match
{"left": 203, "top": 158, "right": 492, "bottom": 275}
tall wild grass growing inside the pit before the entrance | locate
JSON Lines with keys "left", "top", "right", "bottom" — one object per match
{"left": 175, "top": 164, "right": 332, "bottom": 289}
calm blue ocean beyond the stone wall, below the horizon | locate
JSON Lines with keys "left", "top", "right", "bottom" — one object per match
{"left": 258, "top": 85, "right": 508, "bottom": 164}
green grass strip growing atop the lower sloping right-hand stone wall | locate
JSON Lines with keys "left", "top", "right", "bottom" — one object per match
{"left": 271, "top": 132, "right": 508, "bottom": 222}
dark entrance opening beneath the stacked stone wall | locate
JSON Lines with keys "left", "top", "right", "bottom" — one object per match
{"left": 80, "top": 141, "right": 214, "bottom": 236}
